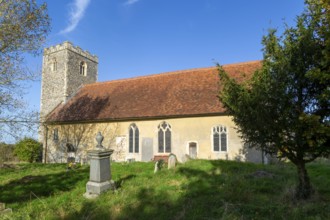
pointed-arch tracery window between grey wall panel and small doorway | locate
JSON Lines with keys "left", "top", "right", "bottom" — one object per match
{"left": 158, "top": 121, "right": 172, "bottom": 153}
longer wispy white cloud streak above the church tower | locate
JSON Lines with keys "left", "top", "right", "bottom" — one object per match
{"left": 60, "top": 0, "right": 91, "bottom": 34}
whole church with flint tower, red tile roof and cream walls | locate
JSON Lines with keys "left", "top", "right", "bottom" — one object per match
{"left": 40, "top": 42, "right": 262, "bottom": 162}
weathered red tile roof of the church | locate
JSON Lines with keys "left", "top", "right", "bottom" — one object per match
{"left": 47, "top": 61, "right": 261, "bottom": 123}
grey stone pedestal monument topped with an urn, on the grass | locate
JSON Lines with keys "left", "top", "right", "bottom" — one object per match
{"left": 84, "top": 132, "right": 113, "bottom": 198}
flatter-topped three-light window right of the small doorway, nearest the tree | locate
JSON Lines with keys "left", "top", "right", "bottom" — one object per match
{"left": 212, "top": 125, "right": 227, "bottom": 152}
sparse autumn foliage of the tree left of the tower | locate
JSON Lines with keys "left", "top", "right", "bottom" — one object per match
{"left": 0, "top": 0, "right": 50, "bottom": 138}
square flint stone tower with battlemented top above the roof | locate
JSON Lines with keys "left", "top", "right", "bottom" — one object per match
{"left": 40, "top": 41, "right": 98, "bottom": 122}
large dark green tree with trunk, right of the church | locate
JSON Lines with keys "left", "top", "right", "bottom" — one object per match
{"left": 219, "top": 0, "right": 330, "bottom": 199}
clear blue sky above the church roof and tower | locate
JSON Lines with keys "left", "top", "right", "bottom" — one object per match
{"left": 26, "top": 0, "right": 304, "bottom": 110}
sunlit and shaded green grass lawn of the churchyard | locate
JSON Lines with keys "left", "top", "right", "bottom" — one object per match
{"left": 0, "top": 160, "right": 330, "bottom": 220}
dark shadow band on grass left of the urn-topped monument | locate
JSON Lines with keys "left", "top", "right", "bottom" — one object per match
{"left": 0, "top": 167, "right": 89, "bottom": 204}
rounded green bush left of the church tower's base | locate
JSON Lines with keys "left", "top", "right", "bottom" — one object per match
{"left": 14, "top": 137, "right": 42, "bottom": 163}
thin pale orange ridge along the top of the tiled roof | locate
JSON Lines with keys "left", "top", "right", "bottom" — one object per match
{"left": 84, "top": 60, "right": 261, "bottom": 87}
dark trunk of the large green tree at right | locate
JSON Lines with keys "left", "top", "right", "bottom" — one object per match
{"left": 296, "top": 162, "right": 312, "bottom": 199}
